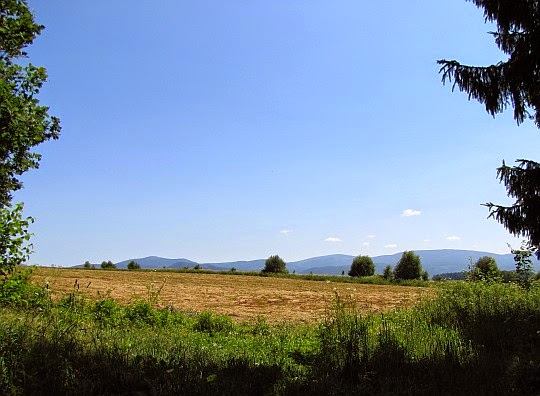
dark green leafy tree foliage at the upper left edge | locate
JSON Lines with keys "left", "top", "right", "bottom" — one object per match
{"left": 0, "top": 0, "right": 60, "bottom": 208}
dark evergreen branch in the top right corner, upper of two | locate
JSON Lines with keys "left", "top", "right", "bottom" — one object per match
{"left": 438, "top": 0, "right": 540, "bottom": 127}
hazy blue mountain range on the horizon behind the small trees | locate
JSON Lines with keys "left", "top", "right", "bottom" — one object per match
{"left": 74, "top": 249, "right": 540, "bottom": 276}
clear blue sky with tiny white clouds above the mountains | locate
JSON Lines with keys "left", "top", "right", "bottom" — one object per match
{"left": 15, "top": 0, "right": 540, "bottom": 266}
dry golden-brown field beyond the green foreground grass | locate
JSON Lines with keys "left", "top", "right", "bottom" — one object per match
{"left": 32, "top": 268, "right": 430, "bottom": 323}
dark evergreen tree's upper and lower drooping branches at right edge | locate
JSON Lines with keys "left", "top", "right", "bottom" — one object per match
{"left": 438, "top": 0, "right": 540, "bottom": 258}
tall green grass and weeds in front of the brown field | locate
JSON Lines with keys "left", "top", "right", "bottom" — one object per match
{"left": 0, "top": 270, "right": 540, "bottom": 395}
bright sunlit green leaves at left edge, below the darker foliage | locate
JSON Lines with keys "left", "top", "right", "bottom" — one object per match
{"left": 0, "top": 204, "right": 34, "bottom": 277}
